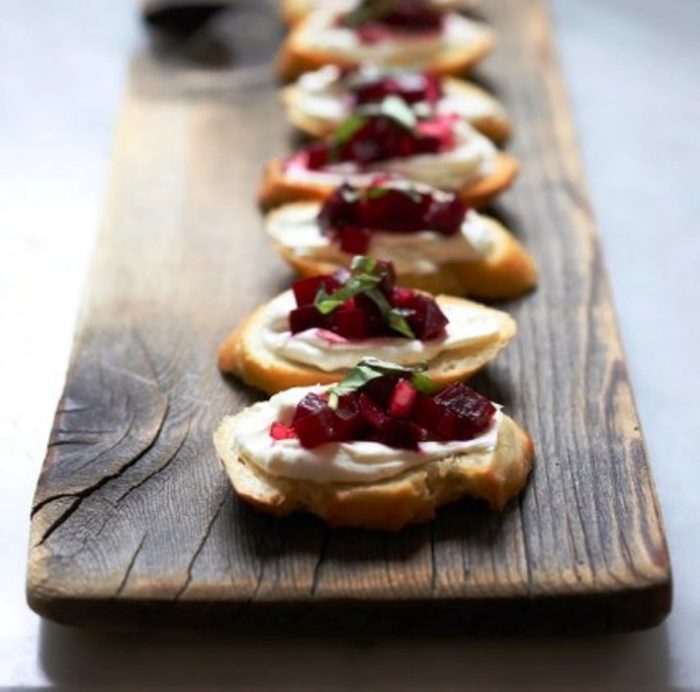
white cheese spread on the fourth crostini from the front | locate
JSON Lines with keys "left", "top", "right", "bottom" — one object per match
{"left": 285, "top": 120, "right": 498, "bottom": 190}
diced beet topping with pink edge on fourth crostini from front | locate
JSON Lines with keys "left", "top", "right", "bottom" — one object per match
{"left": 285, "top": 95, "right": 457, "bottom": 170}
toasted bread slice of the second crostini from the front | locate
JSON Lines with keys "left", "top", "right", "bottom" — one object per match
{"left": 218, "top": 296, "right": 517, "bottom": 394}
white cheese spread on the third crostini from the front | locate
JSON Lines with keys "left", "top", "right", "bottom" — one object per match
{"left": 265, "top": 202, "right": 495, "bottom": 274}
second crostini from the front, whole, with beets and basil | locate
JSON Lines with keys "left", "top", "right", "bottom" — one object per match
{"left": 219, "top": 256, "right": 516, "bottom": 394}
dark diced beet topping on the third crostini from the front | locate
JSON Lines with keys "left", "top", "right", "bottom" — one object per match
{"left": 318, "top": 177, "right": 468, "bottom": 254}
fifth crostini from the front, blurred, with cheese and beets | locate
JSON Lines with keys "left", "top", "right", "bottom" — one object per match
{"left": 282, "top": 65, "right": 512, "bottom": 144}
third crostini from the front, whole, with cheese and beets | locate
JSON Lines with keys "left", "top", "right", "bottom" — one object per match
{"left": 265, "top": 178, "right": 537, "bottom": 300}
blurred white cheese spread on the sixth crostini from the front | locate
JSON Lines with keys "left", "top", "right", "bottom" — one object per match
{"left": 297, "top": 8, "right": 490, "bottom": 67}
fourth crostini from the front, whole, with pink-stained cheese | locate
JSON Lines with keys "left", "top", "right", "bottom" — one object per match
{"left": 258, "top": 96, "right": 518, "bottom": 209}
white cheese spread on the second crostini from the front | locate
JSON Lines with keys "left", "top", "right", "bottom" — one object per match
{"left": 261, "top": 291, "right": 499, "bottom": 372}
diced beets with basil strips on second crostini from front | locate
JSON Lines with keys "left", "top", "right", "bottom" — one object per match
{"left": 289, "top": 257, "right": 448, "bottom": 343}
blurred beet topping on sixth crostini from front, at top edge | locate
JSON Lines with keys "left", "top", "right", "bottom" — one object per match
{"left": 338, "top": 0, "right": 443, "bottom": 44}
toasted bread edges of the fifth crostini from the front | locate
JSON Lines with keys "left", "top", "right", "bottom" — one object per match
{"left": 280, "top": 77, "right": 513, "bottom": 144}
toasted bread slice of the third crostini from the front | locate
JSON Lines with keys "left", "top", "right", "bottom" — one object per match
{"left": 270, "top": 202, "right": 537, "bottom": 300}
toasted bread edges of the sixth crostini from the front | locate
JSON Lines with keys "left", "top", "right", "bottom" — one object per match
{"left": 277, "top": 15, "right": 495, "bottom": 81}
